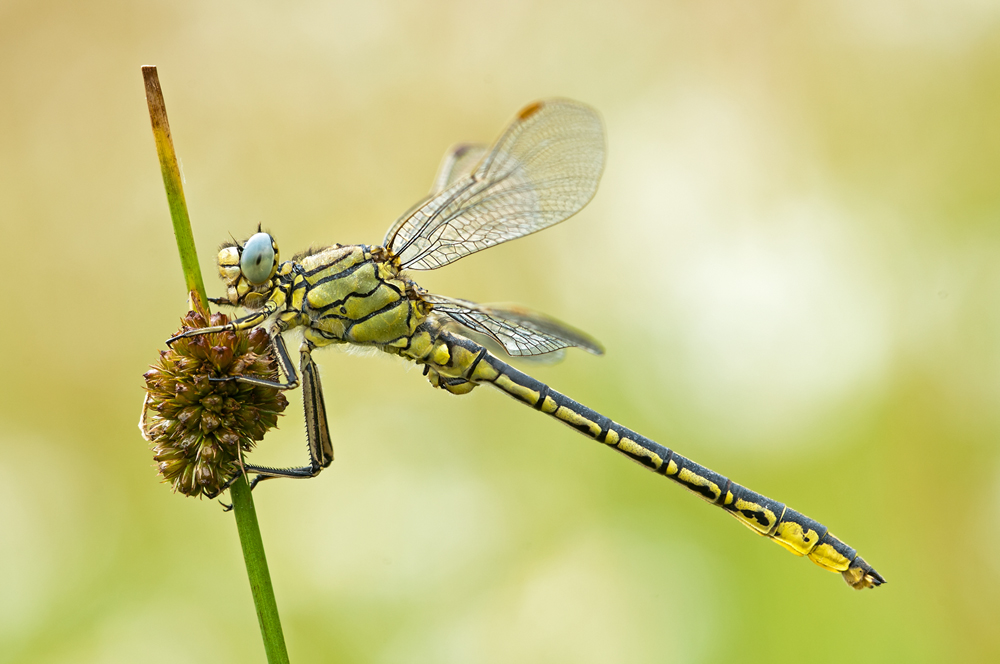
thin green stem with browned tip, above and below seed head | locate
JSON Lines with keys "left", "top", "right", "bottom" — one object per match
{"left": 142, "top": 66, "right": 288, "bottom": 664}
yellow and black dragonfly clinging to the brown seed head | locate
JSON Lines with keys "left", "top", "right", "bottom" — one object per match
{"left": 167, "top": 99, "right": 885, "bottom": 589}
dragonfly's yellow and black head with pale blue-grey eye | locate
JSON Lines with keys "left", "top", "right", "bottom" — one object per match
{"left": 217, "top": 231, "right": 278, "bottom": 309}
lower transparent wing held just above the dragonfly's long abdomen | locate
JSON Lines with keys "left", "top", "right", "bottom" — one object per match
{"left": 422, "top": 293, "right": 604, "bottom": 357}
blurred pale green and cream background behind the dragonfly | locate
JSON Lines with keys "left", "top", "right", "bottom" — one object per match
{"left": 0, "top": 0, "right": 1000, "bottom": 664}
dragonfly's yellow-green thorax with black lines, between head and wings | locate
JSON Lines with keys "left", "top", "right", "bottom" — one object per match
{"left": 300, "top": 245, "right": 421, "bottom": 347}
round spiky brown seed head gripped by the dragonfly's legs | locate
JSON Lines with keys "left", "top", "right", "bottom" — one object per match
{"left": 139, "top": 311, "right": 288, "bottom": 497}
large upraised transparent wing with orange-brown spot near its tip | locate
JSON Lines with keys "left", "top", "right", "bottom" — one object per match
{"left": 385, "top": 99, "right": 604, "bottom": 270}
